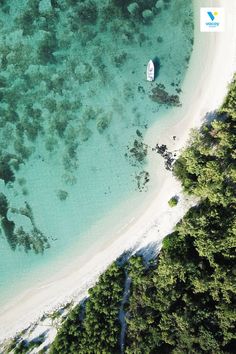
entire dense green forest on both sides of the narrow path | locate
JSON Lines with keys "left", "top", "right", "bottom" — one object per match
{"left": 51, "top": 80, "right": 236, "bottom": 354}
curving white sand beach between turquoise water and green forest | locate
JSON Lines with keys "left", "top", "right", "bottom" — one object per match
{"left": 0, "top": 0, "right": 236, "bottom": 340}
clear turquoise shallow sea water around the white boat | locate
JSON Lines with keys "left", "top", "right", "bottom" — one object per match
{"left": 0, "top": 0, "right": 193, "bottom": 303}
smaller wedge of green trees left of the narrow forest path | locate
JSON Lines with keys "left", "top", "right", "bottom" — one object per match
{"left": 50, "top": 263, "right": 124, "bottom": 354}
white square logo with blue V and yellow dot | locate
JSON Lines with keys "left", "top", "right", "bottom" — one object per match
{"left": 200, "top": 7, "right": 224, "bottom": 32}
